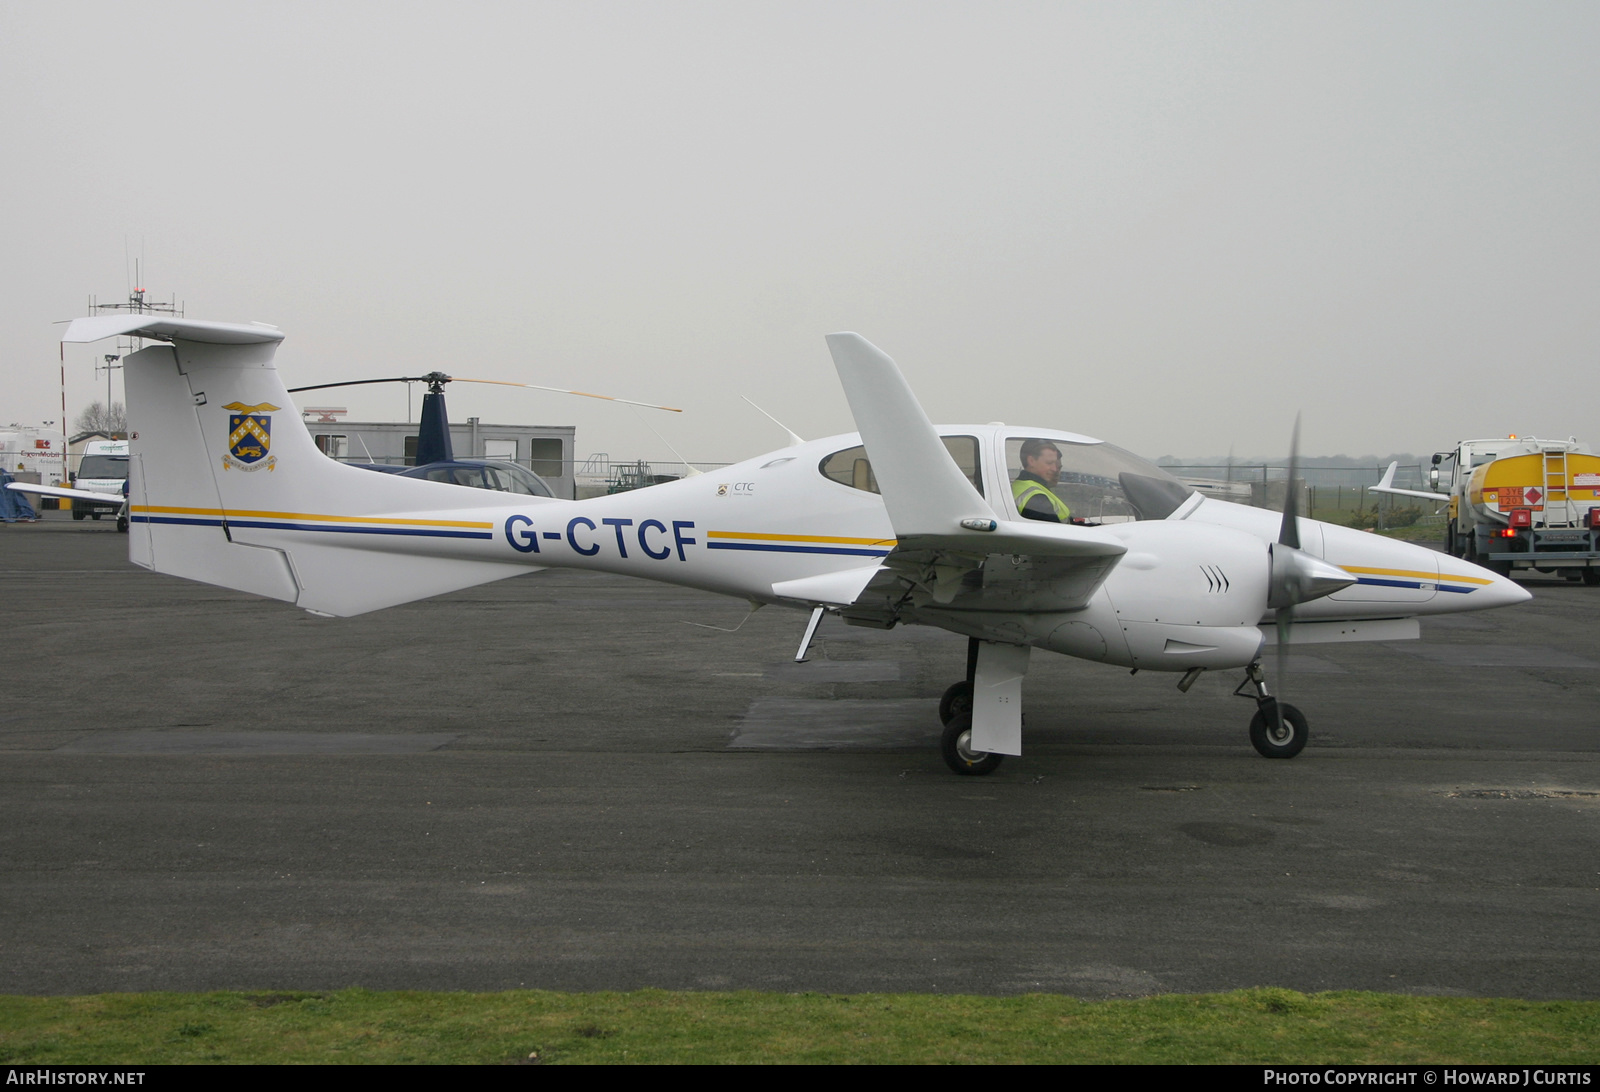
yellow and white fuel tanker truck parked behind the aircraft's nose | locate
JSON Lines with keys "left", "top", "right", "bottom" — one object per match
{"left": 1370, "top": 436, "right": 1600, "bottom": 584}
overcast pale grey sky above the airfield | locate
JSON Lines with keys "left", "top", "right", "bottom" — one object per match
{"left": 0, "top": 0, "right": 1600, "bottom": 460}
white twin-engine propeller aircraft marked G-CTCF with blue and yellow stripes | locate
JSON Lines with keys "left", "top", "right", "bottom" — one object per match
{"left": 62, "top": 315, "right": 1528, "bottom": 773}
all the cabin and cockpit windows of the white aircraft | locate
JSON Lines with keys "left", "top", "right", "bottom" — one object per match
{"left": 818, "top": 432, "right": 1194, "bottom": 524}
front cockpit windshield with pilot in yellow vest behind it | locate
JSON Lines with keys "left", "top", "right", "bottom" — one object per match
{"left": 1005, "top": 436, "right": 1194, "bottom": 524}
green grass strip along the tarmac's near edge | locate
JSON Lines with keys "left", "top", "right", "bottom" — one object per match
{"left": 0, "top": 990, "right": 1600, "bottom": 1065}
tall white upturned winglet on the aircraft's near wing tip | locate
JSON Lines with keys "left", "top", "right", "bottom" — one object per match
{"left": 827, "top": 333, "right": 995, "bottom": 535}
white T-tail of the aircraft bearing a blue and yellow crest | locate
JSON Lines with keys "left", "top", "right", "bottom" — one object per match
{"left": 62, "top": 315, "right": 528, "bottom": 615}
